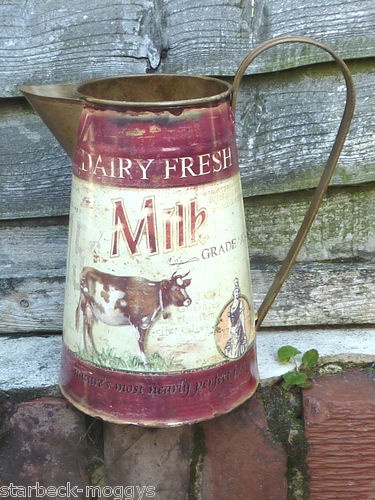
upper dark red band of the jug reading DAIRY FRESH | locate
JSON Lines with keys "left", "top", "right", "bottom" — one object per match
{"left": 73, "top": 100, "right": 238, "bottom": 188}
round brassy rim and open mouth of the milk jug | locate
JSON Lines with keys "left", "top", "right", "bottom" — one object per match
{"left": 75, "top": 73, "right": 233, "bottom": 109}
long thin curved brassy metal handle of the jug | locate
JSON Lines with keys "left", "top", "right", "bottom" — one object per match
{"left": 232, "top": 35, "right": 355, "bottom": 330}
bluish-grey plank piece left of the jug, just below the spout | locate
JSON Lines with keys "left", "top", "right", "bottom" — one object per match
{"left": 0, "top": 99, "right": 71, "bottom": 219}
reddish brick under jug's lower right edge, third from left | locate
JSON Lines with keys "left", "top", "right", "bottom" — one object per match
{"left": 202, "top": 395, "right": 287, "bottom": 500}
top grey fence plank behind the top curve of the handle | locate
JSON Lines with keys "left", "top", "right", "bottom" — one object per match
{"left": 161, "top": 0, "right": 375, "bottom": 75}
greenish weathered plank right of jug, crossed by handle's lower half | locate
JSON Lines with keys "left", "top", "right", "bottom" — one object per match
{"left": 245, "top": 184, "right": 375, "bottom": 264}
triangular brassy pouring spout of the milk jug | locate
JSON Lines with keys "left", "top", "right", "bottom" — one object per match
{"left": 20, "top": 84, "right": 83, "bottom": 157}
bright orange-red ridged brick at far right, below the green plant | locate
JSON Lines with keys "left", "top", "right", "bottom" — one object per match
{"left": 303, "top": 370, "right": 375, "bottom": 500}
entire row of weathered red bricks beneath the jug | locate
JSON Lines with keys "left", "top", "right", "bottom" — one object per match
{"left": 0, "top": 364, "right": 375, "bottom": 500}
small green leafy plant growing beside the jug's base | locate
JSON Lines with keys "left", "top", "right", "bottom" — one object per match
{"left": 277, "top": 345, "right": 319, "bottom": 388}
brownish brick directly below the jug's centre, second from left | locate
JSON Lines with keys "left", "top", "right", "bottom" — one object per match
{"left": 104, "top": 424, "right": 192, "bottom": 500}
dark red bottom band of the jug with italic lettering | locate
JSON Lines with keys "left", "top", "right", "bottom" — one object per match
{"left": 60, "top": 342, "right": 258, "bottom": 427}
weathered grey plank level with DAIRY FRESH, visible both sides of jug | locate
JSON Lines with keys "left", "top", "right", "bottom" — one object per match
{"left": 0, "top": 62, "right": 375, "bottom": 219}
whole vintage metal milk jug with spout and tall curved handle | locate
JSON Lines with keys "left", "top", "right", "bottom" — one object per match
{"left": 21, "top": 36, "right": 354, "bottom": 426}
